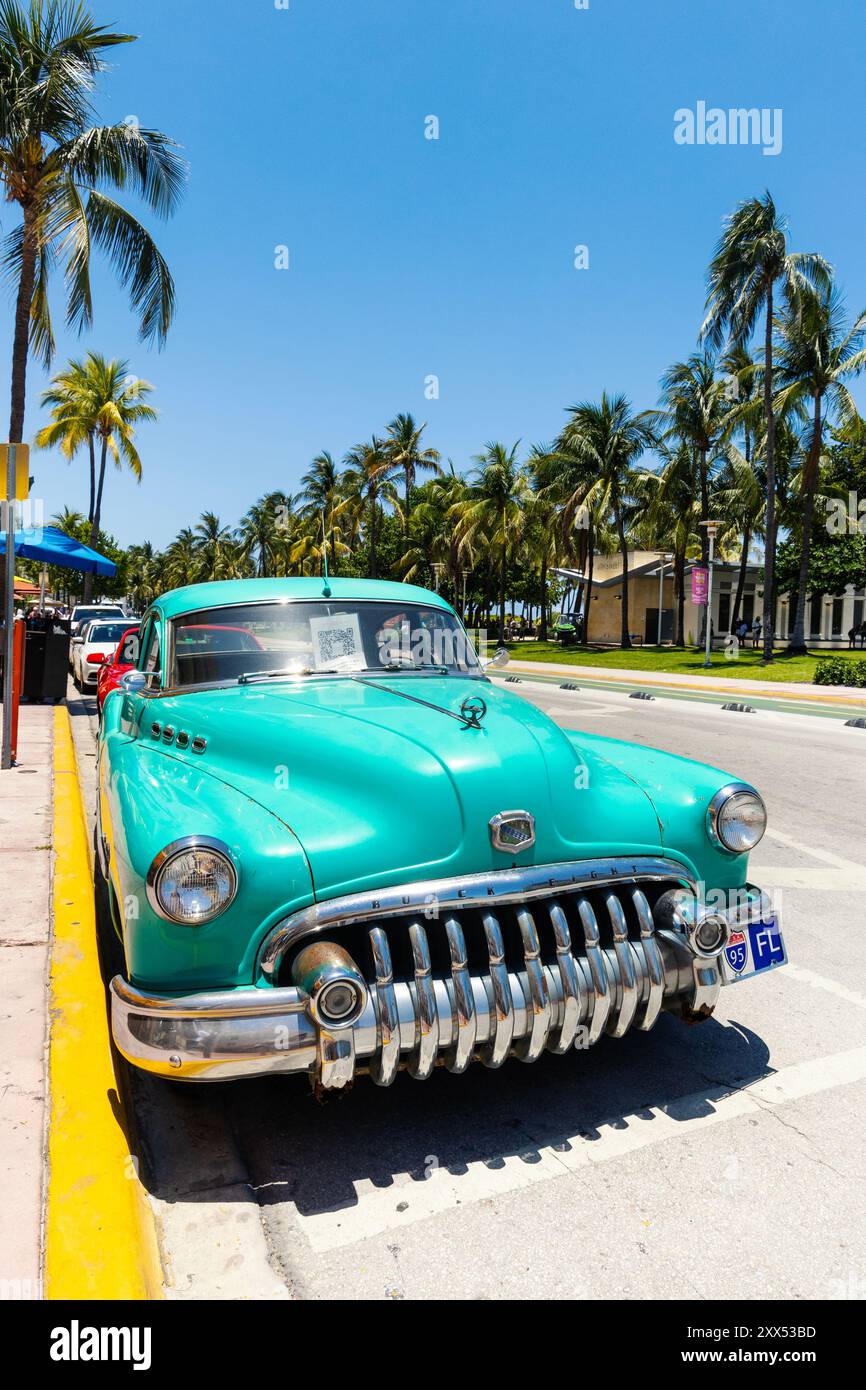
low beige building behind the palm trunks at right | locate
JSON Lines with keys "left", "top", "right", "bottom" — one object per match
{"left": 553, "top": 550, "right": 866, "bottom": 648}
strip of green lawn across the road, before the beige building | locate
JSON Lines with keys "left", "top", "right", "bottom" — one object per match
{"left": 507, "top": 642, "right": 866, "bottom": 683}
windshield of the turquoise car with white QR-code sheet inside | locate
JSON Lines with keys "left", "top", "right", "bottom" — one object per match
{"left": 171, "top": 599, "right": 481, "bottom": 685}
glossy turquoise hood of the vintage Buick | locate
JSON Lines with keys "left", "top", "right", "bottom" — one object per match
{"left": 152, "top": 676, "right": 662, "bottom": 898}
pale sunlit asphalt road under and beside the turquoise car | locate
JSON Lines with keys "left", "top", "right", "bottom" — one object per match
{"left": 70, "top": 681, "right": 866, "bottom": 1301}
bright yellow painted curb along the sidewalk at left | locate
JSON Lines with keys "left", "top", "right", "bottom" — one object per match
{"left": 44, "top": 706, "right": 163, "bottom": 1300}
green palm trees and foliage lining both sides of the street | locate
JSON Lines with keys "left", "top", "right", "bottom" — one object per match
{"left": 0, "top": 0, "right": 866, "bottom": 686}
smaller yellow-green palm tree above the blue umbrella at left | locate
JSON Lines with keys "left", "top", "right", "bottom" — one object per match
{"left": 36, "top": 352, "right": 157, "bottom": 602}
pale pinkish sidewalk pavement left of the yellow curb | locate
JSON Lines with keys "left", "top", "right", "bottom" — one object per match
{"left": 0, "top": 705, "right": 54, "bottom": 1298}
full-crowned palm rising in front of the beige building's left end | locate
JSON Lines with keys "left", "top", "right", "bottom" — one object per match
{"left": 560, "top": 392, "right": 657, "bottom": 648}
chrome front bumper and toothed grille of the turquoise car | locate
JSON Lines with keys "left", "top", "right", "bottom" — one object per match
{"left": 111, "top": 860, "right": 766, "bottom": 1090}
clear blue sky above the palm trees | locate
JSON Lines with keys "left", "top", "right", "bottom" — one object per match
{"left": 0, "top": 0, "right": 866, "bottom": 546}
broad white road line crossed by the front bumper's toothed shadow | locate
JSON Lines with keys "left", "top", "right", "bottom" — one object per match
{"left": 295, "top": 1047, "right": 866, "bottom": 1254}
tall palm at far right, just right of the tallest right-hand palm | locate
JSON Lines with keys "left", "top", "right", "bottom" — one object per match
{"left": 774, "top": 288, "right": 866, "bottom": 655}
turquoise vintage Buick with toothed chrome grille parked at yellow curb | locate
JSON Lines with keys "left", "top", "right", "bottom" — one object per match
{"left": 97, "top": 578, "right": 785, "bottom": 1088}
